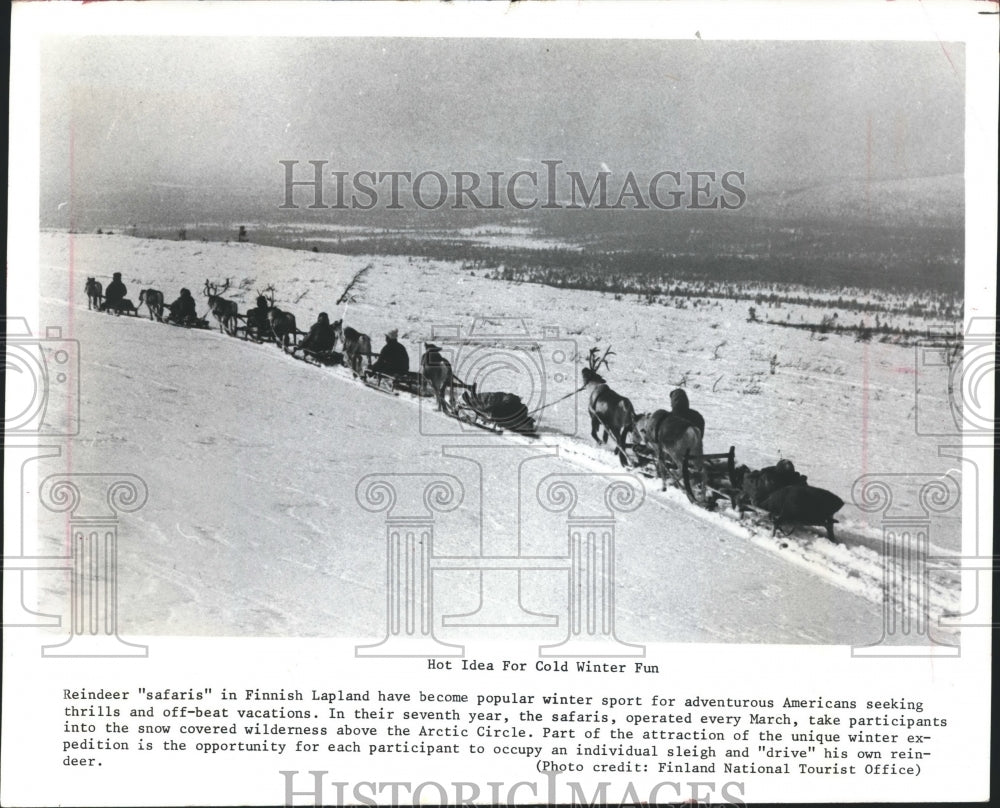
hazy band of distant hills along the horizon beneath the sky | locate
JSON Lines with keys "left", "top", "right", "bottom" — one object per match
{"left": 40, "top": 174, "right": 965, "bottom": 237}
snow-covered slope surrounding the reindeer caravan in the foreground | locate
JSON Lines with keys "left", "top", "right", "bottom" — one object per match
{"left": 33, "top": 233, "right": 961, "bottom": 644}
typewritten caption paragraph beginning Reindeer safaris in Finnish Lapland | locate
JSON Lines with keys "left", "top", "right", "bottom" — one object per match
{"left": 60, "top": 686, "right": 948, "bottom": 777}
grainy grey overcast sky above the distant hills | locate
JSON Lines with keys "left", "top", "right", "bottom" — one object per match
{"left": 41, "top": 37, "right": 965, "bottom": 218}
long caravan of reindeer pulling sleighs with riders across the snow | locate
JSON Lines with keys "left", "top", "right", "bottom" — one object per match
{"left": 86, "top": 272, "right": 844, "bottom": 541}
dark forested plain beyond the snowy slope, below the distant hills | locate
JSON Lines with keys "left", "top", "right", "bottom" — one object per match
{"left": 107, "top": 217, "right": 964, "bottom": 302}
